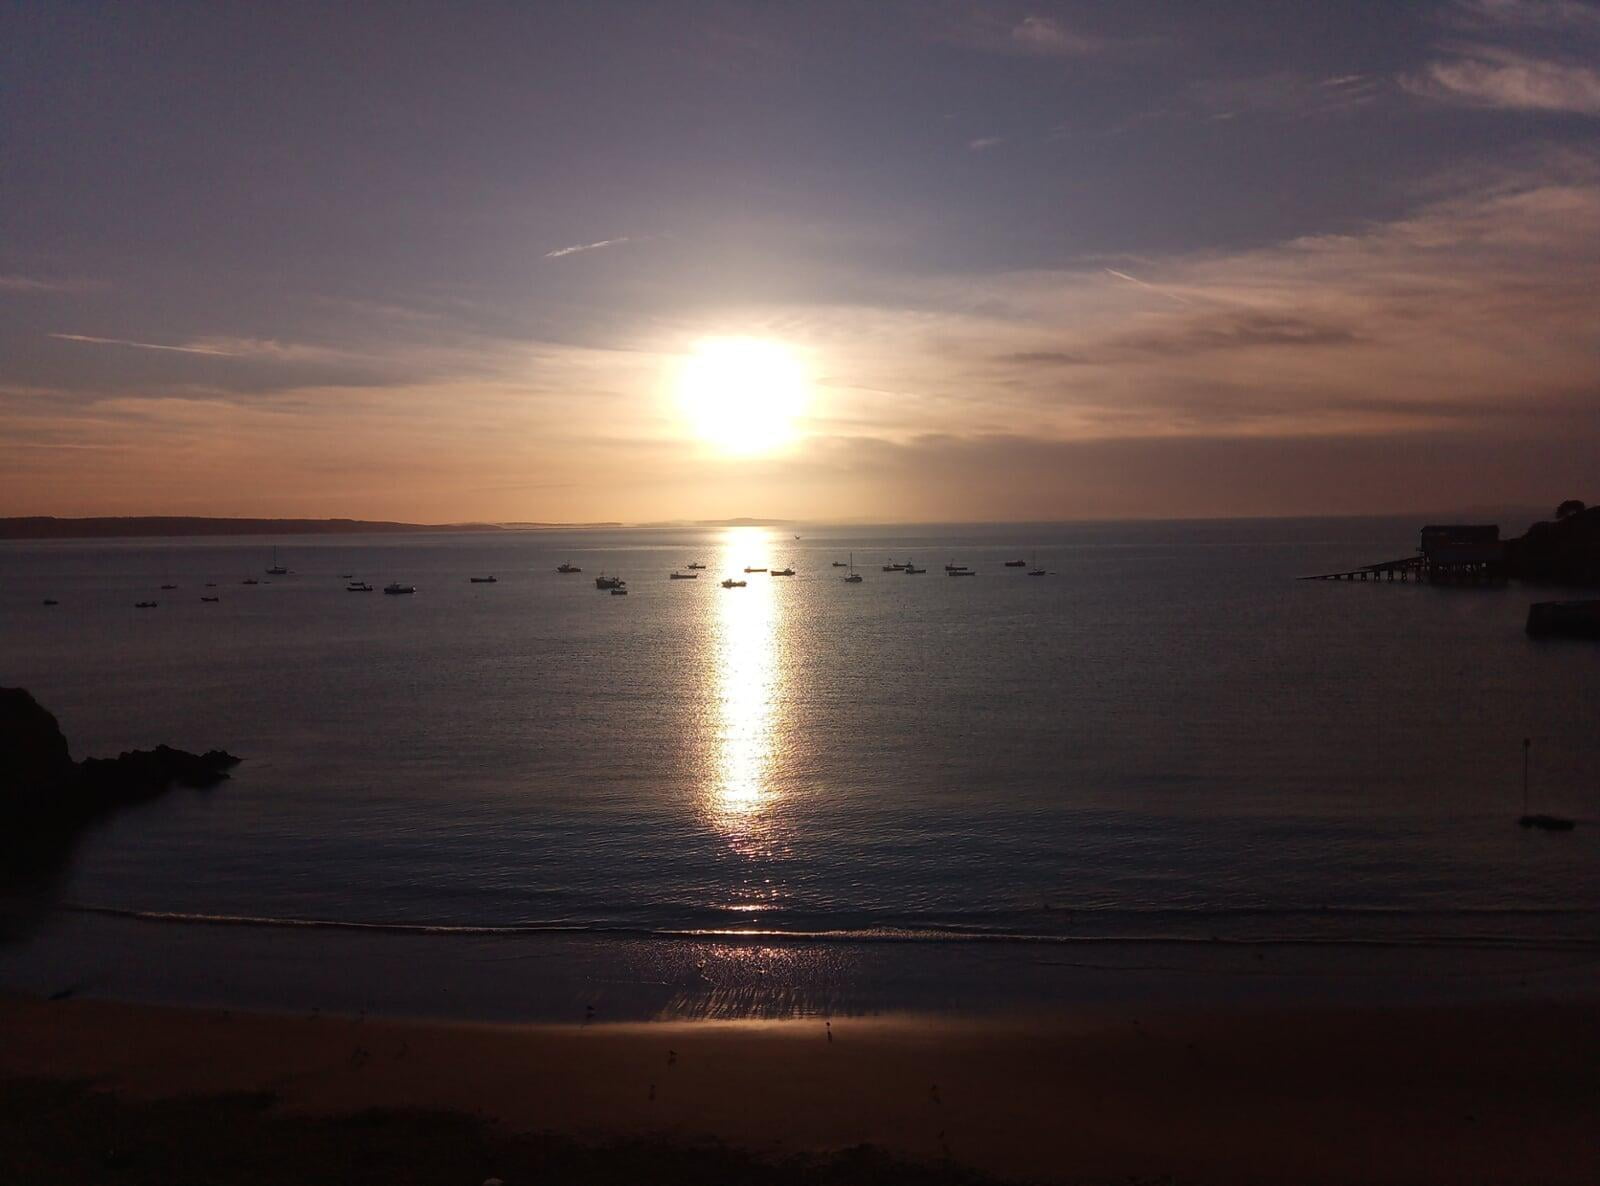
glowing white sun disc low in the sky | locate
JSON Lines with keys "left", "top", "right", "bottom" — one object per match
{"left": 678, "top": 338, "right": 806, "bottom": 455}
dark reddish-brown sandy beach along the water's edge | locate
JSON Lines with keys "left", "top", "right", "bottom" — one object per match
{"left": 0, "top": 997, "right": 1600, "bottom": 1183}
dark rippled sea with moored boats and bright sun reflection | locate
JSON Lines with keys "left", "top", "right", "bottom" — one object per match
{"left": 0, "top": 519, "right": 1600, "bottom": 1020}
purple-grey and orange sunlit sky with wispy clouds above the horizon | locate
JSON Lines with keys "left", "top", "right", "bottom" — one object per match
{"left": 0, "top": 0, "right": 1600, "bottom": 522}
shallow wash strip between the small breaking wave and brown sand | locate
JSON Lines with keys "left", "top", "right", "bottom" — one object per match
{"left": 0, "top": 909, "right": 1600, "bottom": 1023}
